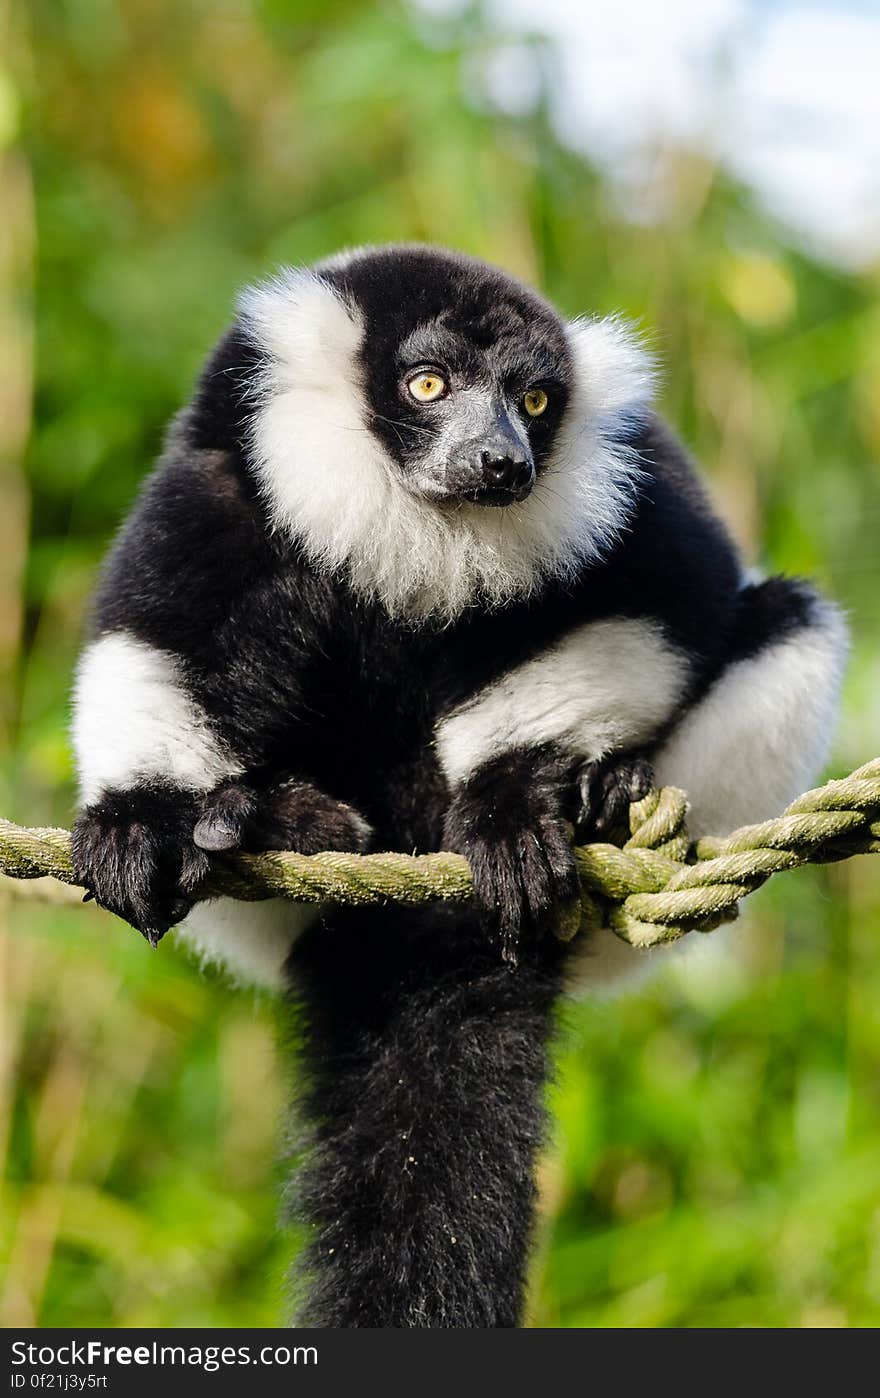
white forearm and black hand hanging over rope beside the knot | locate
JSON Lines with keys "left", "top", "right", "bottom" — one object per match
{"left": 437, "top": 618, "right": 691, "bottom": 960}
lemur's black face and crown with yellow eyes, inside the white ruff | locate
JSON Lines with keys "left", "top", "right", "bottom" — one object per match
{"left": 318, "top": 249, "right": 572, "bottom": 506}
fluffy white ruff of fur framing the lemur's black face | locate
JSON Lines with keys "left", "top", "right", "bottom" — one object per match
{"left": 241, "top": 271, "right": 652, "bottom": 619}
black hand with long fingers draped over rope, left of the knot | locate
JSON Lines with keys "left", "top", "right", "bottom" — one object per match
{"left": 443, "top": 752, "right": 579, "bottom": 965}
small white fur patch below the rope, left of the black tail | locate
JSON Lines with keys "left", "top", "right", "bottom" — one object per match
{"left": 175, "top": 898, "right": 313, "bottom": 990}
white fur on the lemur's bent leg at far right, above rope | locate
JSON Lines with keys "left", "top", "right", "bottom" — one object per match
{"left": 655, "top": 604, "right": 846, "bottom": 836}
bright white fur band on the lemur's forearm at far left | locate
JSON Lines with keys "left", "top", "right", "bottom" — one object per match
{"left": 71, "top": 630, "right": 241, "bottom": 804}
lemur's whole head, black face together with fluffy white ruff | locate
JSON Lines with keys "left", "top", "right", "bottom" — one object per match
{"left": 237, "top": 246, "right": 651, "bottom": 618}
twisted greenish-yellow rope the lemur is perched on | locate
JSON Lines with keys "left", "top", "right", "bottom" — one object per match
{"left": 0, "top": 758, "right": 880, "bottom": 946}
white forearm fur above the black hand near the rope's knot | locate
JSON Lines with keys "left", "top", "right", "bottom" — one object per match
{"left": 437, "top": 618, "right": 688, "bottom": 781}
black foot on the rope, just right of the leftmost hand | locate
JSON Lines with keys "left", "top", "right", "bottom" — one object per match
{"left": 193, "top": 780, "right": 372, "bottom": 854}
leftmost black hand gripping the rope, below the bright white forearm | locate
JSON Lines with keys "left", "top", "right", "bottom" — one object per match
{"left": 71, "top": 786, "right": 208, "bottom": 946}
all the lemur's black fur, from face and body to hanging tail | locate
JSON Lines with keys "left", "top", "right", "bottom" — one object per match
{"left": 74, "top": 249, "right": 845, "bottom": 1327}
